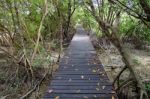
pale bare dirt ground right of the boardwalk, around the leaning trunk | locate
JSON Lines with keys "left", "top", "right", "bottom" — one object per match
{"left": 97, "top": 45, "right": 150, "bottom": 82}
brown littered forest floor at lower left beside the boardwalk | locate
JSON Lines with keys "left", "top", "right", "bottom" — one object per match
{"left": 0, "top": 51, "right": 59, "bottom": 99}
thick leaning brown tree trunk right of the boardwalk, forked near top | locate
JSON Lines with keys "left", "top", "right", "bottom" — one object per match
{"left": 87, "top": 0, "right": 148, "bottom": 99}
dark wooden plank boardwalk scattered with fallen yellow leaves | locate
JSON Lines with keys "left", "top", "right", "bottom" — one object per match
{"left": 43, "top": 28, "right": 117, "bottom": 99}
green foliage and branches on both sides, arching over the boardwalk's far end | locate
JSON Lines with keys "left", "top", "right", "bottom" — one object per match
{"left": 0, "top": 0, "right": 150, "bottom": 98}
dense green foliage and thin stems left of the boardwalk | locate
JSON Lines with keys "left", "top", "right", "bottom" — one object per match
{"left": 0, "top": 0, "right": 76, "bottom": 98}
